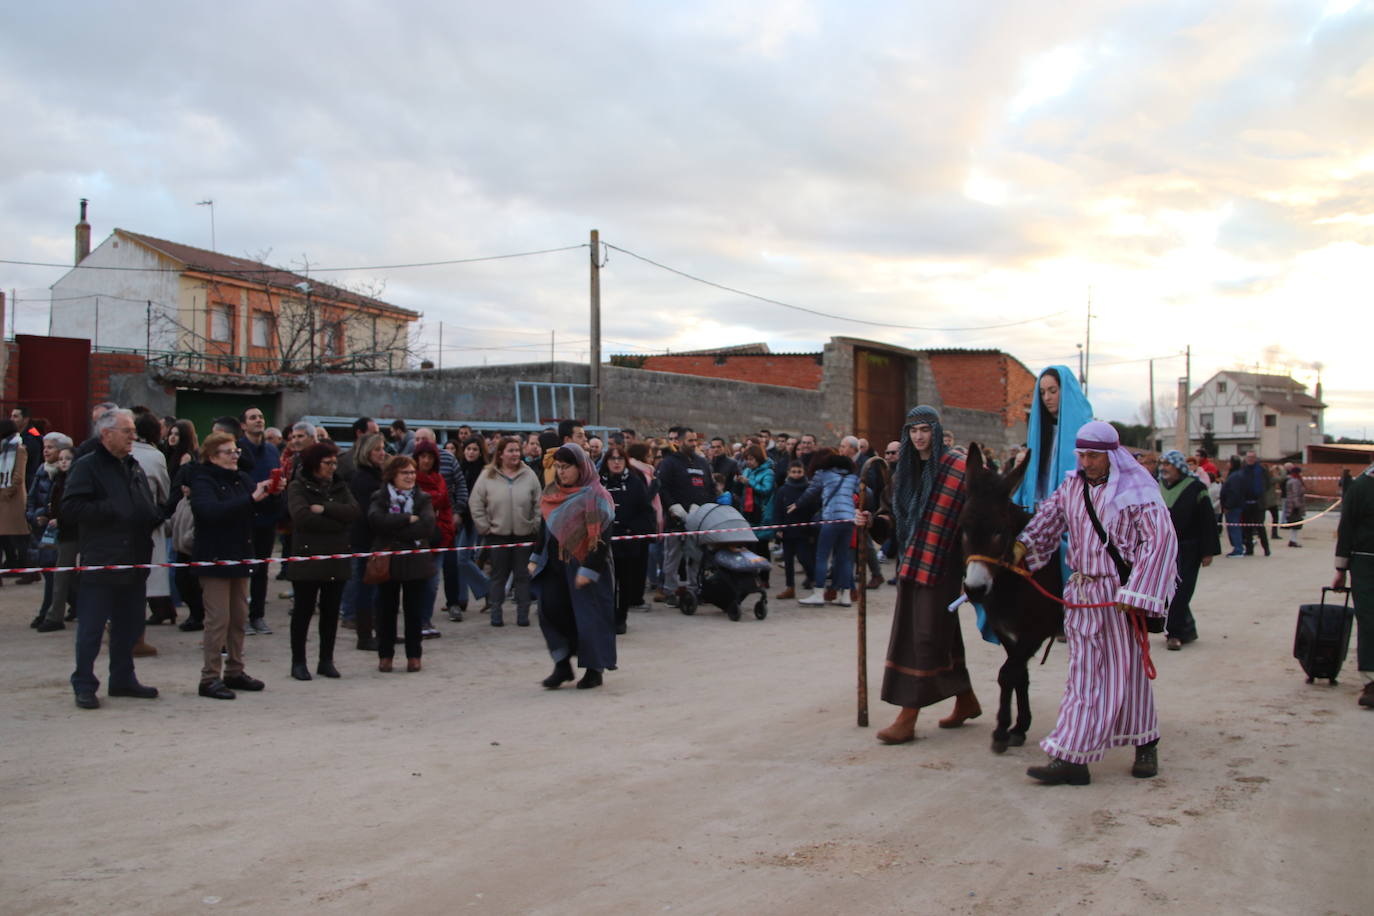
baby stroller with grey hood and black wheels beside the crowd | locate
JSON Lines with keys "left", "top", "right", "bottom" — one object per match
{"left": 677, "top": 503, "right": 768, "bottom": 621}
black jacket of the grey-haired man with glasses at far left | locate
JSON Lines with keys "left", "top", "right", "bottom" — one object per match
{"left": 62, "top": 442, "right": 164, "bottom": 585}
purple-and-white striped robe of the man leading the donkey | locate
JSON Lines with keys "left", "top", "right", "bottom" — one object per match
{"left": 1018, "top": 475, "right": 1178, "bottom": 764}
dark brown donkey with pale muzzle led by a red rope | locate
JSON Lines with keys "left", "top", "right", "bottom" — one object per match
{"left": 959, "top": 444, "right": 1063, "bottom": 754}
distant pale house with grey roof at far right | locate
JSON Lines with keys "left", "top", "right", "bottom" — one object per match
{"left": 1189, "top": 369, "right": 1326, "bottom": 461}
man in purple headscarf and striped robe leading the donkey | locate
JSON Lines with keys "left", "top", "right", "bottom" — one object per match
{"left": 1015, "top": 420, "right": 1178, "bottom": 786}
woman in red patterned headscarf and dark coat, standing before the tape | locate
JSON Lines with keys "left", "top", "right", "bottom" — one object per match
{"left": 530, "top": 442, "right": 616, "bottom": 689}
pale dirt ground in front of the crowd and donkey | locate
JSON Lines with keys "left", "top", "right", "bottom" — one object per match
{"left": 0, "top": 518, "right": 1374, "bottom": 916}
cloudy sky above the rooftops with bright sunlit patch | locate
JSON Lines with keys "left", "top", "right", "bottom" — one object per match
{"left": 0, "top": 0, "right": 1374, "bottom": 435}
